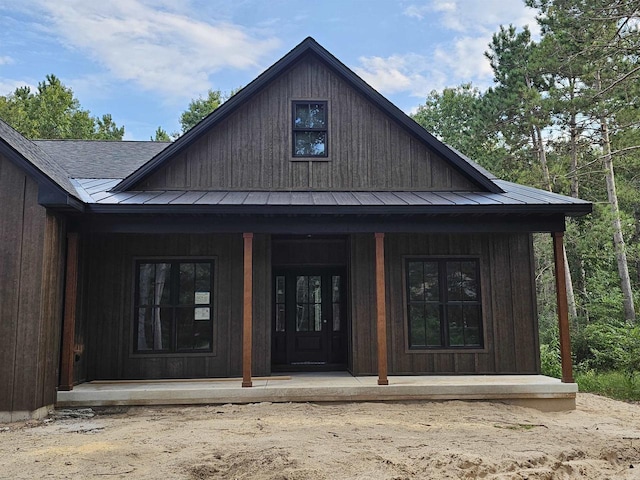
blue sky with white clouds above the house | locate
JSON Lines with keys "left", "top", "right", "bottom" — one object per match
{"left": 0, "top": 0, "right": 539, "bottom": 140}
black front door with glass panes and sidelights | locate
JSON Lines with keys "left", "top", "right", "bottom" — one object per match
{"left": 271, "top": 267, "right": 347, "bottom": 370}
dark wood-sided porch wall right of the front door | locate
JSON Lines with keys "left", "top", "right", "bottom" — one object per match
{"left": 351, "top": 234, "right": 540, "bottom": 374}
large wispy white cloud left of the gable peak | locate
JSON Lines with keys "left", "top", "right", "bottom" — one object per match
{"left": 20, "top": 0, "right": 279, "bottom": 99}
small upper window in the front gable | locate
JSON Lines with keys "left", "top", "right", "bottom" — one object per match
{"left": 293, "top": 102, "right": 327, "bottom": 157}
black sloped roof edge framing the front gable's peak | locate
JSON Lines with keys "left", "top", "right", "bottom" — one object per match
{"left": 113, "top": 37, "right": 502, "bottom": 193}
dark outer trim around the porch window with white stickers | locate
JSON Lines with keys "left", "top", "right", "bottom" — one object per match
{"left": 126, "top": 255, "right": 220, "bottom": 358}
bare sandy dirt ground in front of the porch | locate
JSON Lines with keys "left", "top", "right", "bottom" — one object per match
{"left": 0, "top": 394, "right": 640, "bottom": 480}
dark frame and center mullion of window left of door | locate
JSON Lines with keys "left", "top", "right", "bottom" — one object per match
{"left": 128, "top": 256, "right": 219, "bottom": 358}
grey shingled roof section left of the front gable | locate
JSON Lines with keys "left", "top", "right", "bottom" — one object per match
{"left": 33, "top": 140, "right": 171, "bottom": 179}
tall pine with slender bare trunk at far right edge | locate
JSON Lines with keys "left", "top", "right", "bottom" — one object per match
{"left": 527, "top": 0, "right": 640, "bottom": 322}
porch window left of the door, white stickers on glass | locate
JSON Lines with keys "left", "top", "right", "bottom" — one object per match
{"left": 134, "top": 260, "right": 214, "bottom": 353}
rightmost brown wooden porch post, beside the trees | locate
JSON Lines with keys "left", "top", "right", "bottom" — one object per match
{"left": 551, "top": 232, "right": 573, "bottom": 383}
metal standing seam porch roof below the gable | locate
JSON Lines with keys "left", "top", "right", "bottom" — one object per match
{"left": 74, "top": 178, "right": 591, "bottom": 215}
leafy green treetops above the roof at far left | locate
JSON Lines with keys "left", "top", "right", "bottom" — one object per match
{"left": 0, "top": 75, "right": 124, "bottom": 140}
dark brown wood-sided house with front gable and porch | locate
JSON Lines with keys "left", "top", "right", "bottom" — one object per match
{"left": 0, "top": 38, "right": 591, "bottom": 418}
